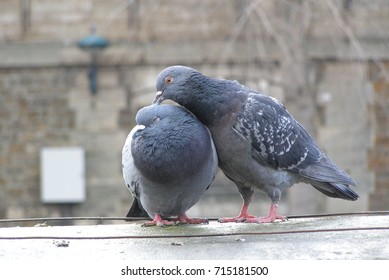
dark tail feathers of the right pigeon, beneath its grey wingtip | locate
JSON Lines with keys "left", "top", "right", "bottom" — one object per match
{"left": 310, "top": 181, "right": 359, "bottom": 201}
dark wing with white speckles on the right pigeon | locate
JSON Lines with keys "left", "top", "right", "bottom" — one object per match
{"left": 234, "top": 93, "right": 336, "bottom": 180}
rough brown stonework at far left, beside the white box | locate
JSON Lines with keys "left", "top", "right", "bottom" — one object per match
{"left": 0, "top": 68, "right": 75, "bottom": 217}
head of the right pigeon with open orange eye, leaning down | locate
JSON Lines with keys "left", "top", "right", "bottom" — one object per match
{"left": 153, "top": 65, "right": 202, "bottom": 105}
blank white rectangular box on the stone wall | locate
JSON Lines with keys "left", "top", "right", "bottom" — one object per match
{"left": 40, "top": 147, "right": 85, "bottom": 203}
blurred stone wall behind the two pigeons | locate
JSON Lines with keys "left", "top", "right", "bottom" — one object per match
{"left": 0, "top": 0, "right": 389, "bottom": 223}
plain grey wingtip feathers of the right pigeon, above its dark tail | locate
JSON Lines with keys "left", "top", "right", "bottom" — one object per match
{"left": 299, "top": 156, "right": 356, "bottom": 186}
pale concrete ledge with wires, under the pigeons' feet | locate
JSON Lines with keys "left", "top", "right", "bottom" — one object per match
{"left": 0, "top": 212, "right": 389, "bottom": 260}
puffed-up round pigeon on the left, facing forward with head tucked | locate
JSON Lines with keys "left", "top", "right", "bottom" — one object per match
{"left": 122, "top": 105, "right": 218, "bottom": 226}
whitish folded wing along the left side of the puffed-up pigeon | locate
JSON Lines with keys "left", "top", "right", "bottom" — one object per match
{"left": 122, "top": 125, "right": 144, "bottom": 197}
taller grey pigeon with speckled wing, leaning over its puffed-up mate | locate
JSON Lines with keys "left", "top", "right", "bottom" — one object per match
{"left": 153, "top": 66, "right": 358, "bottom": 223}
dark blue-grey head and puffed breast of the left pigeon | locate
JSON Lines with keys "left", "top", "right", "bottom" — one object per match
{"left": 130, "top": 104, "right": 213, "bottom": 183}
